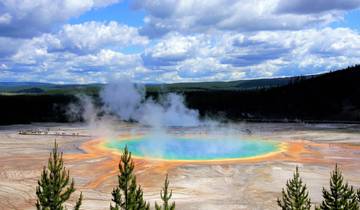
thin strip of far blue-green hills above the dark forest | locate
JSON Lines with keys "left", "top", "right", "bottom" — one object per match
{"left": 0, "top": 76, "right": 311, "bottom": 94}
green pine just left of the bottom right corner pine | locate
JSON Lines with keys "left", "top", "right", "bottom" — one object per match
{"left": 277, "top": 167, "right": 311, "bottom": 210}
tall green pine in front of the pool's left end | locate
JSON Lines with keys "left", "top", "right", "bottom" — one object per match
{"left": 110, "top": 147, "right": 150, "bottom": 210}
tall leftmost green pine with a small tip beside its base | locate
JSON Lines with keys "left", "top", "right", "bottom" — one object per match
{"left": 36, "top": 141, "right": 83, "bottom": 210}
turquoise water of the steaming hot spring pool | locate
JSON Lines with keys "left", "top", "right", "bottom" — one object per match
{"left": 106, "top": 136, "right": 279, "bottom": 160}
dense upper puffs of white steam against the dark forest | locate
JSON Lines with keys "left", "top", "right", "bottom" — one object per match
{"left": 100, "top": 80, "right": 201, "bottom": 127}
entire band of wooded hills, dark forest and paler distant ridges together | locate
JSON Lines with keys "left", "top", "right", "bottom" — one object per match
{"left": 0, "top": 65, "right": 360, "bottom": 124}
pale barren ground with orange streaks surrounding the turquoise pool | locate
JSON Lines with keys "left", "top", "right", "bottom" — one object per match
{"left": 0, "top": 123, "right": 360, "bottom": 210}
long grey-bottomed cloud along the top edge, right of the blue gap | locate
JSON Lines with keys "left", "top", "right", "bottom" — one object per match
{"left": 134, "top": 0, "right": 342, "bottom": 37}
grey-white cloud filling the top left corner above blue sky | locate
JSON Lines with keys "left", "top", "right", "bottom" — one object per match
{"left": 0, "top": 0, "right": 119, "bottom": 37}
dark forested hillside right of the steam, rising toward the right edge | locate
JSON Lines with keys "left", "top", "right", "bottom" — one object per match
{"left": 185, "top": 65, "right": 360, "bottom": 123}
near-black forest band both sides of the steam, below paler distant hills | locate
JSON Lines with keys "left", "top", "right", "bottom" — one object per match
{"left": 0, "top": 65, "right": 360, "bottom": 125}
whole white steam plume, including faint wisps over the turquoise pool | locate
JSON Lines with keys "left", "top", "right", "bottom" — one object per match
{"left": 69, "top": 80, "right": 253, "bottom": 157}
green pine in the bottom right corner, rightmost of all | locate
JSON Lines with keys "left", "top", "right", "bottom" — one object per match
{"left": 320, "top": 164, "right": 359, "bottom": 210}
